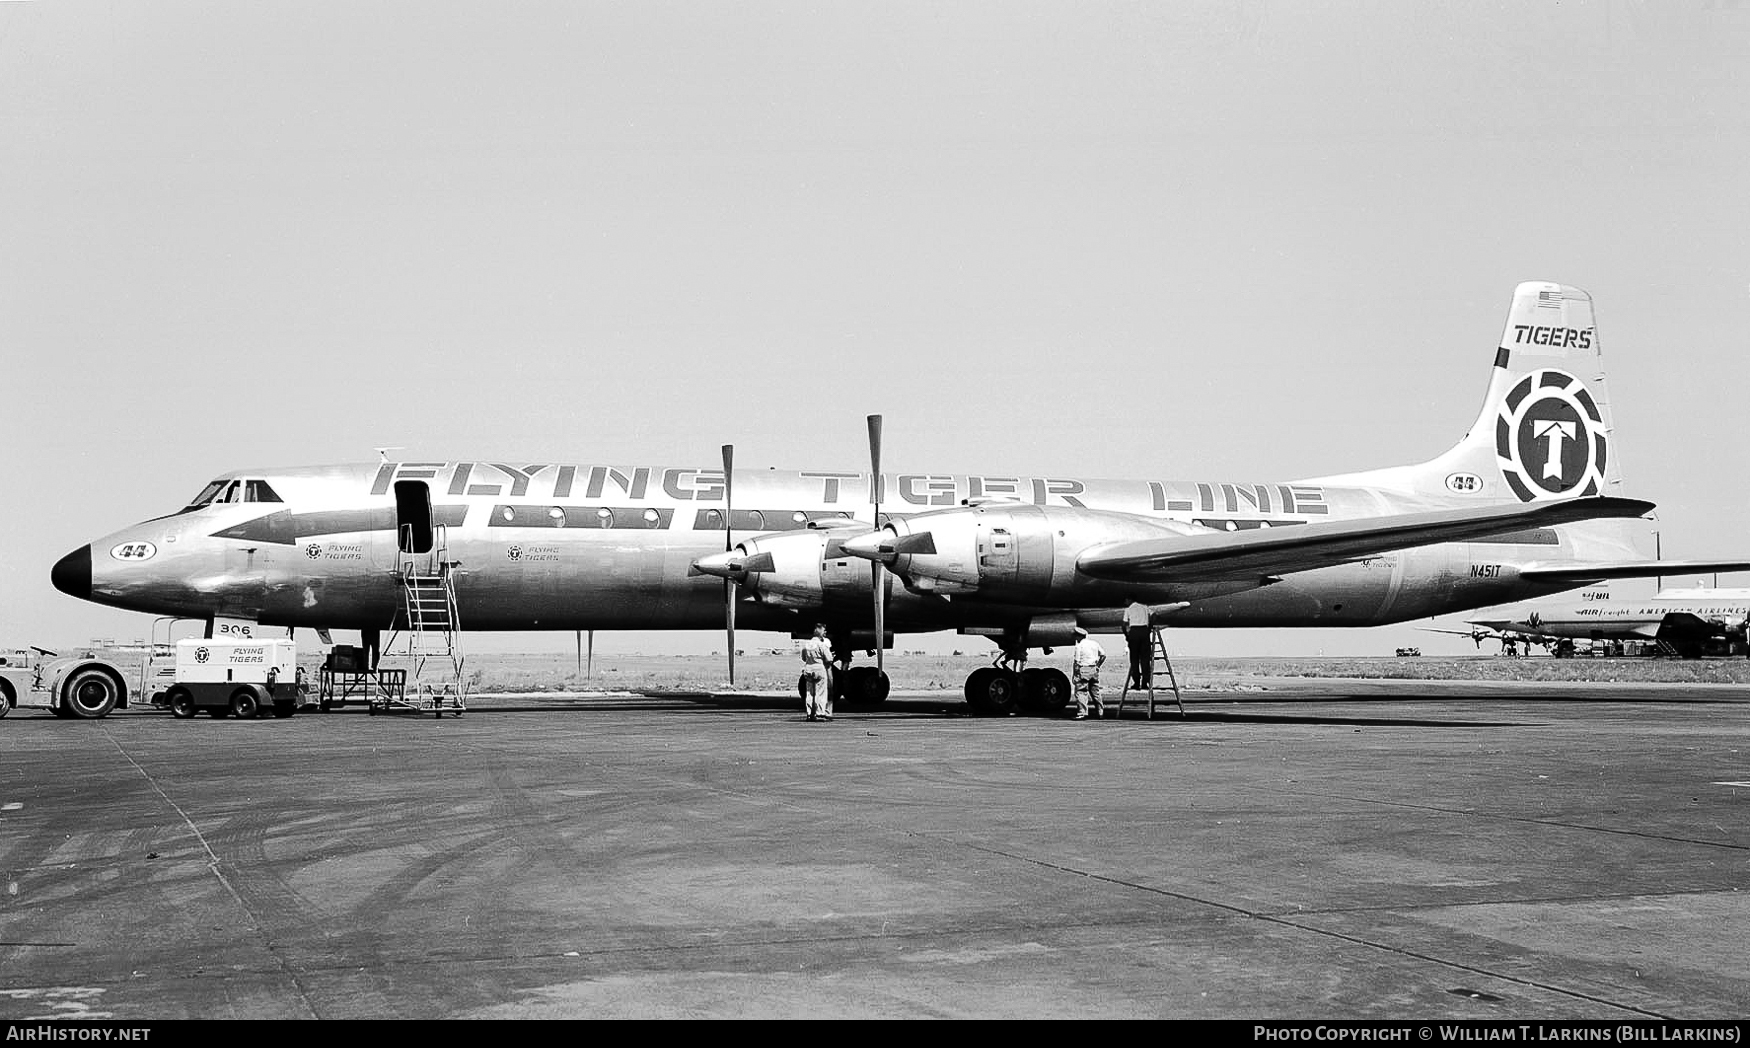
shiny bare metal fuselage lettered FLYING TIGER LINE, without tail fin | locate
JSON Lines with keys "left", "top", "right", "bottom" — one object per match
{"left": 71, "top": 462, "right": 1572, "bottom": 632}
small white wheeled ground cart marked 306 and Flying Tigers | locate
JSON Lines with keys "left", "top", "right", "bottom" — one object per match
{"left": 166, "top": 639, "right": 305, "bottom": 719}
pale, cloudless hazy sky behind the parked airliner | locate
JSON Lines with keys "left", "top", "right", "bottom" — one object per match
{"left": 0, "top": 0, "right": 1750, "bottom": 654}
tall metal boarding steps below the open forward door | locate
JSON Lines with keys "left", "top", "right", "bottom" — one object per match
{"left": 369, "top": 527, "right": 467, "bottom": 717}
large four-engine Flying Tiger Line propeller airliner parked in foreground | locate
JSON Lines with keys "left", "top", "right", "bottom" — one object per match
{"left": 53, "top": 283, "right": 1750, "bottom": 712}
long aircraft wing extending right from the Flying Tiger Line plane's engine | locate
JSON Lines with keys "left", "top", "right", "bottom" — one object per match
{"left": 1076, "top": 495, "right": 1654, "bottom": 583}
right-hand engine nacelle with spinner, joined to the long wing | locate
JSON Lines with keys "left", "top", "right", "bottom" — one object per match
{"left": 844, "top": 502, "right": 1209, "bottom": 607}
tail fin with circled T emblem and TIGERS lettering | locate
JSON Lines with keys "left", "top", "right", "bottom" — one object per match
{"left": 1323, "top": 282, "right": 1624, "bottom": 502}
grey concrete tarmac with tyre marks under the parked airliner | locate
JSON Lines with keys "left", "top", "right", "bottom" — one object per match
{"left": 0, "top": 679, "right": 1750, "bottom": 1020}
